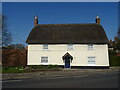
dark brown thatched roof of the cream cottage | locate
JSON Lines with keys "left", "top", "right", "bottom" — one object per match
{"left": 26, "top": 23, "right": 108, "bottom": 44}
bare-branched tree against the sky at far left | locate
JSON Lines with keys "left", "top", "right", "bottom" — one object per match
{"left": 2, "top": 16, "right": 12, "bottom": 47}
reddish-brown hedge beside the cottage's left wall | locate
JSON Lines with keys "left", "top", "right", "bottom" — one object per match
{"left": 2, "top": 49, "right": 27, "bottom": 67}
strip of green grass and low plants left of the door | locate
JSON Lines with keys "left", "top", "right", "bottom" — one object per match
{"left": 2, "top": 65, "right": 62, "bottom": 73}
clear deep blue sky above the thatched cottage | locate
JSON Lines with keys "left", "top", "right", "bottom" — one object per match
{"left": 2, "top": 2, "right": 118, "bottom": 45}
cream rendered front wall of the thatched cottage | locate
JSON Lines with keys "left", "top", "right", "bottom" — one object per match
{"left": 27, "top": 44, "right": 109, "bottom": 66}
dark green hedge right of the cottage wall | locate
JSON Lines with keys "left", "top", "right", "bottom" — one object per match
{"left": 109, "top": 55, "right": 120, "bottom": 66}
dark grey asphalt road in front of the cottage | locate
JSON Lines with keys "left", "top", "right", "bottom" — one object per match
{"left": 2, "top": 72, "right": 118, "bottom": 88}
